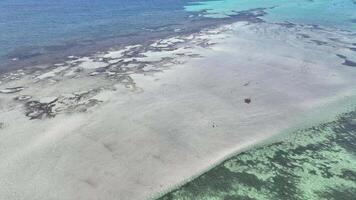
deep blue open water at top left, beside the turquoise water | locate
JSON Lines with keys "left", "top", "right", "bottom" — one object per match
{"left": 0, "top": 0, "right": 200, "bottom": 61}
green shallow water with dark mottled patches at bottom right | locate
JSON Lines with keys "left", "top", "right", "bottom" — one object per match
{"left": 159, "top": 111, "right": 356, "bottom": 200}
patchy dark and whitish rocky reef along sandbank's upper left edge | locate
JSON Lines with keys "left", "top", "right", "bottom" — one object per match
{"left": 0, "top": 29, "right": 217, "bottom": 120}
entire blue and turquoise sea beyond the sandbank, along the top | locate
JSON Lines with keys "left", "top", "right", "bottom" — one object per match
{"left": 0, "top": 0, "right": 356, "bottom": 70}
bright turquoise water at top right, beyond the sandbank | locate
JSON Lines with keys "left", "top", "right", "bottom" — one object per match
{"left": 185, "top": 0, "right": 356, "bottom": 31}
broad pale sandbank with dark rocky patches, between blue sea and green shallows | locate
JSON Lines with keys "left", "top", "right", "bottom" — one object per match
{"left": 0, "top": 22, "right": 356, "bottom": 200}
